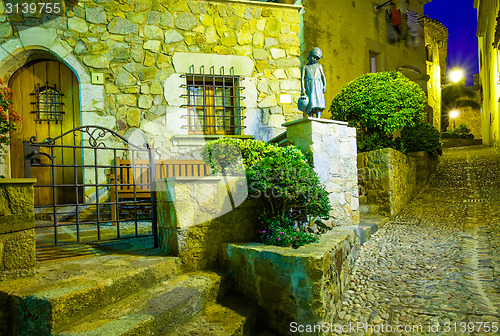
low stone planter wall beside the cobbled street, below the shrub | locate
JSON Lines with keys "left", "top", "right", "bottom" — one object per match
{"left": 228, "top": 226, "right": 359, "bottom": 335}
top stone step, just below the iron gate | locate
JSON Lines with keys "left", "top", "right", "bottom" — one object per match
{"left": 0, "top": 255, "right": 181, "bottom": 336}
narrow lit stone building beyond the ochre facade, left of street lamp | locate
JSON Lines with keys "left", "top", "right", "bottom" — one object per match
{"left": 424, "top": 18, "right": 448, "bottom": 131}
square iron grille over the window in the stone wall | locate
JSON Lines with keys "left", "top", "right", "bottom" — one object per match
{"left": 182, "top": 65, "right": 245, "bottom": 135}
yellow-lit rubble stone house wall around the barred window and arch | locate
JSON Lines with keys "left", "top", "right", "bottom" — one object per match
{"left": 0, "top": 0, "right": 301, "bottom": 167}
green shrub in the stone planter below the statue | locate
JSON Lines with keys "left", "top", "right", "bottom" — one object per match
{"left": 202, "top": 138, "right": 331, "bottom": 247}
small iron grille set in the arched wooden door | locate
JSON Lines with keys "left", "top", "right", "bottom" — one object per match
{"left": 30, "top": 82, "right": 64, "bottom": 124}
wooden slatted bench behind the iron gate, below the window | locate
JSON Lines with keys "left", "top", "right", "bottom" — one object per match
{"left": 110, "top": 158, "right": 210, "bottom": 221}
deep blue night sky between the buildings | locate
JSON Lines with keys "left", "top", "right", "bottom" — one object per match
{"left": 424, "top": 0, "right": 479, "bottom": 85}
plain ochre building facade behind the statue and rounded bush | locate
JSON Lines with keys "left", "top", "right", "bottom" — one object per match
{"left": 300, "top": 0, "right": 428, "bottom": 118}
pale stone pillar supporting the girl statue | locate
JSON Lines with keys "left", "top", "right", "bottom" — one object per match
{"left": 283, "top": 118, "right": 359, "bottom": 225}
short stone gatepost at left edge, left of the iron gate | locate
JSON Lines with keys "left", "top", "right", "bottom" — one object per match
{"left": 0, "top": 179, "right": 36, "bottom": 280}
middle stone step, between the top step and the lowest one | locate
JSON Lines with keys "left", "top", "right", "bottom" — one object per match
{"left": 53, "top": 271, "right": 222, "bottom": 336}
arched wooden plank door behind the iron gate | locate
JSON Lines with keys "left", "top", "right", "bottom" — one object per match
{"left": 9, "top": 60, "right": 83, "bottom": 205}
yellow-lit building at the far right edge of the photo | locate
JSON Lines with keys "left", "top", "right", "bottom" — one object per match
{"left": 474, "top": 0, "right": 500, "bottom": 148}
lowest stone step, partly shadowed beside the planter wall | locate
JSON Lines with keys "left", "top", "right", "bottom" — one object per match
{"left": 168, "top": 294, "right": 257, "bottom": 336}
